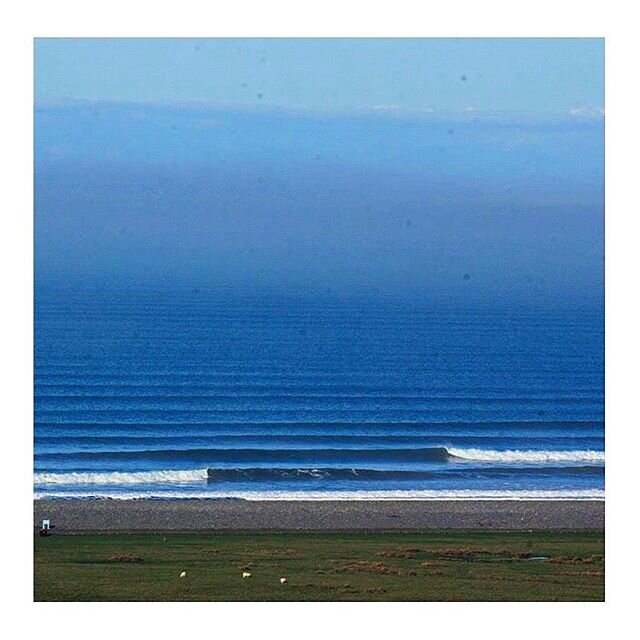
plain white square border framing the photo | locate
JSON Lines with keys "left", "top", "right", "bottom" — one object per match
{"left": 0, "top": 0, "right": 640, "bottom": 640}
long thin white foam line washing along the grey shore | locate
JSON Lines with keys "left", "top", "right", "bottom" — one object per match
{"left": 35, "top": 489, "right": 604, "bottom": 501}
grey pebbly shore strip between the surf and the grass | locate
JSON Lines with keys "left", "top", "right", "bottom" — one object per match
{"left": 34, "top": 500, "right": 604, "bottom": 533}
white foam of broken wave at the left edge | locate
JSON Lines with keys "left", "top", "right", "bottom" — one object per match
{"left": 34, "top": 469, "right": 207, "bottom": 485}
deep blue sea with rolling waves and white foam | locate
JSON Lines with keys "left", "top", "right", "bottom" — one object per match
{"left": 34, "top": 289, "right": 604, "bottom": 499}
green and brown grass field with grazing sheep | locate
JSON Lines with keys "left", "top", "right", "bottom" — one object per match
{"left": 34, "top": 531, "right": 604, "bottom": 601}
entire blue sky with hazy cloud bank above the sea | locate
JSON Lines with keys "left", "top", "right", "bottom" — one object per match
{"left": 35, "top": 39, "right": 604, "bottom": 306}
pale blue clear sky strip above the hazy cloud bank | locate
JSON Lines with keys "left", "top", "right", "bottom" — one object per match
{"left": 35, "top": 38, "right": 604, "bottom": 114}
